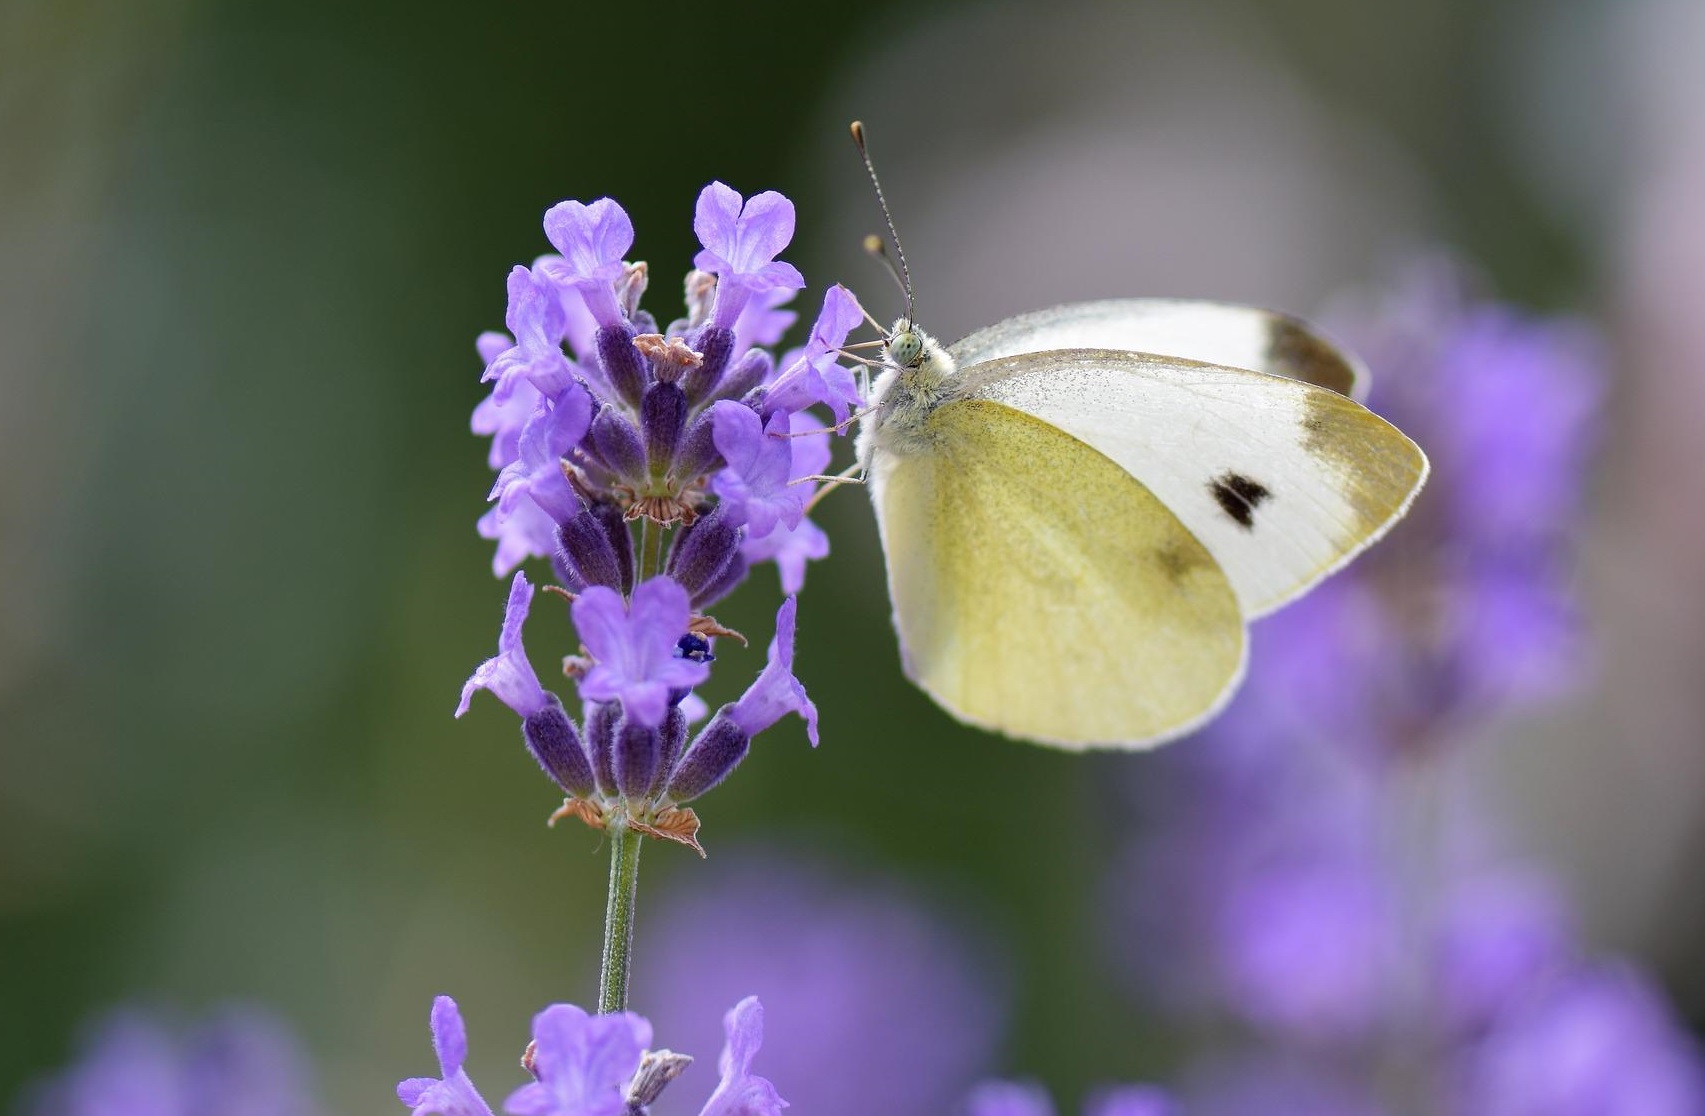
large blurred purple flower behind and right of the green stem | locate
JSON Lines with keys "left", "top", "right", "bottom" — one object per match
{"left": 634, "top": 849, "right": 1003, "bottom": 1116}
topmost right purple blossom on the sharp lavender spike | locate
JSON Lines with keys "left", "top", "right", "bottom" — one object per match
{"left": 692, "top": 182, "right": 805, "bottom": 329}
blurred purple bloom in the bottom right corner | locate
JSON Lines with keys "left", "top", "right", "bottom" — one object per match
{"left": 1458, "top": 966, "right": 1705, "bottom": 1116}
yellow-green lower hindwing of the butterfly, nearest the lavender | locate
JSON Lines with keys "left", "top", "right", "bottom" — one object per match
{"left": 870, "top": 399, "right": 1245, "bottom": 748}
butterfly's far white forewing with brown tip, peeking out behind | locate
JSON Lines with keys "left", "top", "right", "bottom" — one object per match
{"left": 948, "top": 298, "right": 1367, "bottom": 400}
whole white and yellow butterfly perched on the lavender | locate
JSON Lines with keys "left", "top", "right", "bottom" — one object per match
{"left": 859, "top": 300, "right": 1427, "bottom": 748}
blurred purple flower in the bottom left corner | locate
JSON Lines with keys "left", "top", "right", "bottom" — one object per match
{"left": 20, "top": 1007, "right": 321, "bottom": 1116}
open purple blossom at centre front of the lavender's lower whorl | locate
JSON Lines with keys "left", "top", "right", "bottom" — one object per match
{"left": 573, "top": 578, "right": 711, "bottom": 729}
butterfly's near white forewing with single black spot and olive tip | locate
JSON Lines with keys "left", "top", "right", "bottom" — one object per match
{"left": 960, "top": 349, "right": 1427, "bottom": 617}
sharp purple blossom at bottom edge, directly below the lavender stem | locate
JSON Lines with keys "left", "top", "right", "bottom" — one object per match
{"left": 503, "top": 1004, "right": 651, "bottom": 1116}
